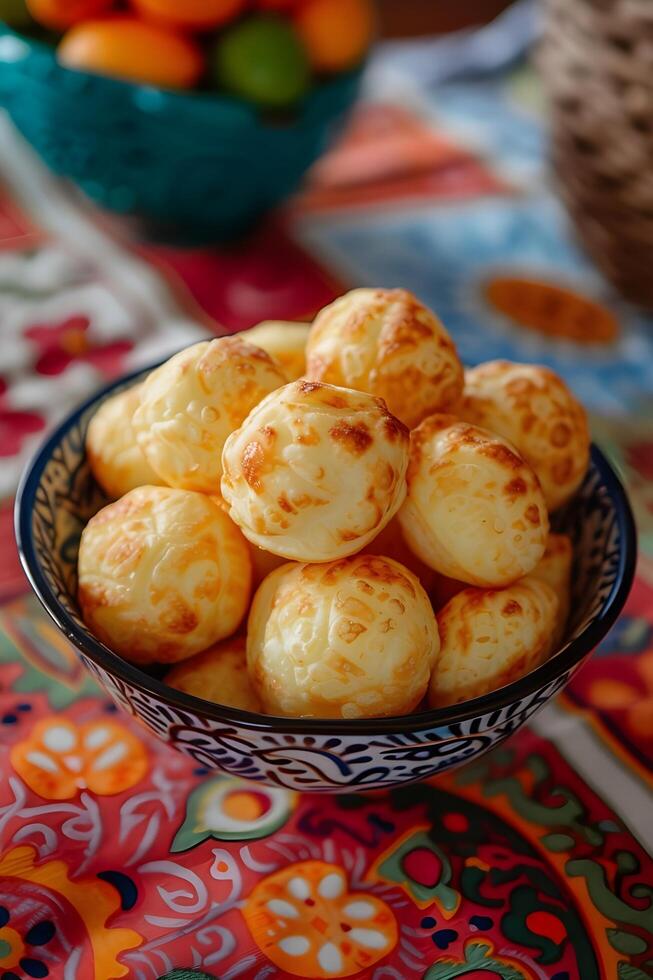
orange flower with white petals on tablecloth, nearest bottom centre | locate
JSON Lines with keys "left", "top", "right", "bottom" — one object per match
{"left": 243, "top": 861, "right": 397, "bottom": 978}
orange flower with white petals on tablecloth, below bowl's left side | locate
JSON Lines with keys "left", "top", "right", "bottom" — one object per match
{"left": 11, "top": 716, "right": 147, "bottom": 800}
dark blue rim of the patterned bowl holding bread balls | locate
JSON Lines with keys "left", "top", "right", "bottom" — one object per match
{"left": 14, "top": 364, "right": 637, "bottom": 736}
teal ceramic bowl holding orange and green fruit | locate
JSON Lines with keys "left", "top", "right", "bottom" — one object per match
{"left": 0, "top": 24, "right": 361, "bottom": 239}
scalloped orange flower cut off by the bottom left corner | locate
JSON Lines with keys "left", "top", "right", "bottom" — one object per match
{"left": 0, "top": 845, "right": 142, "bottom": 980}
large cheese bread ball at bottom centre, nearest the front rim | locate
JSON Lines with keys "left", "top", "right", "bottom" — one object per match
{"left": 247, "top": 555, "right": 439, "bottom": 718}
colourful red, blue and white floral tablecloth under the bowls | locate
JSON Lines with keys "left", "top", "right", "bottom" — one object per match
{"left": 0, "top": 59, "right": 653, "bottom": 980}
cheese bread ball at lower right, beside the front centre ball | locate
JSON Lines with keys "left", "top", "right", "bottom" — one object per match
{"left": 428, "top": 577, "right": 558, "bottom": 708}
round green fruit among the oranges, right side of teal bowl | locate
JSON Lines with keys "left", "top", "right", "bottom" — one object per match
{"left": 209, "top": 14, "right": 310, "bottom": 109}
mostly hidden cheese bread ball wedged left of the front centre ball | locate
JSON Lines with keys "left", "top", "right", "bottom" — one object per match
{"left": 165, "top": 637, "right": 261, "bottom": 712}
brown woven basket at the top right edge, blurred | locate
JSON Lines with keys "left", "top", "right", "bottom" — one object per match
{"left": 539, "top": 0, "right": 653, "bottom": 308}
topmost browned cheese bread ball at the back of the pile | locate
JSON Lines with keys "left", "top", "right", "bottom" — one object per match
{"left": 306, "top": 289, "right": 463, "bottom": 429}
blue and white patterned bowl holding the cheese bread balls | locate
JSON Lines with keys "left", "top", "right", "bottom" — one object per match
{"left": 16, "top": 371, "right": 637, "bottom": 793}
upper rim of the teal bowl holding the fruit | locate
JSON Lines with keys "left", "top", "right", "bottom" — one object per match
{"left": 0, "top": 20, "right": 366, "bottom": 128}
